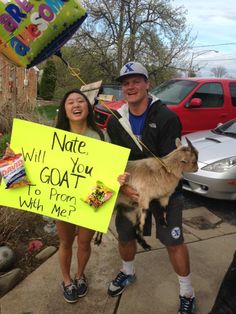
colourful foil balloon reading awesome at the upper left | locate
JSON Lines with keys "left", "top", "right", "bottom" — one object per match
{"left": 0, "top": 0, "right": 87, "bottom": 68}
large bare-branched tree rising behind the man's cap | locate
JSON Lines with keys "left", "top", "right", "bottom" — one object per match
{"left": 71, "top": 0, "right": 192, "bottom": 83}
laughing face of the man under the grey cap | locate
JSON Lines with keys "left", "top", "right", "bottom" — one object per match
{"left": 121, "top": 75, "right": 149, "bottom": 105}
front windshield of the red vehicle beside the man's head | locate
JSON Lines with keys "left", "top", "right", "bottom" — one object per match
{"left": 151, "top": 80, "right": 198, "bottom": 105}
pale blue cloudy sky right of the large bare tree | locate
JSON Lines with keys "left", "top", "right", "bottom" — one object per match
{"left": 172, "top": 0, "right": 236, "bottom": 78}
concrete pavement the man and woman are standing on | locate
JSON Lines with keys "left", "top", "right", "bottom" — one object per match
{"left": 0, "top": 207, "right": 236, "bottom": 314}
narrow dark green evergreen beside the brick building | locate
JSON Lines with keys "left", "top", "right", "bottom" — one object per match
{"left": 39, "top": 58, "right": 57, "bottom": 100}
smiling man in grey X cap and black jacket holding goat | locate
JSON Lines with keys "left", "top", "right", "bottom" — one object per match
{"left": 107, "top": 62, "right": 195, "bottom": 314}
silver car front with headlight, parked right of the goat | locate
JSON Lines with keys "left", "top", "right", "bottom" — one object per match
{"left": 182, "top": 119, "right": 236, "bottom": 201}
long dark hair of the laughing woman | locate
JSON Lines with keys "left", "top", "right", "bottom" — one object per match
{"left": 56, "top": 89, "right": 104, "bottom": 140}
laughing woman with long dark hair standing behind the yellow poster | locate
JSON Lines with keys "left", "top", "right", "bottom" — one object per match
{"left": 56, "top": 89, "right": 109, "bottom": 303}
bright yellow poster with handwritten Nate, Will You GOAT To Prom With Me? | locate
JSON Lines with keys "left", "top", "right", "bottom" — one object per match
{"left": 0, "top": 119, "right": 130, "bottom": 232}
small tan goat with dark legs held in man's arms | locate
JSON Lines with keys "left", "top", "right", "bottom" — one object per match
{"left": 95, "top": 138, "right": 198, "bottom": 250}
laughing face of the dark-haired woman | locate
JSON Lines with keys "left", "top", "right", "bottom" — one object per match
{"left": 65, "top": 93, "right": 88, "bottom": 122}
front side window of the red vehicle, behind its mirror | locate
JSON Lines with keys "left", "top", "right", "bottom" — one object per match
{"left": 192, "top": 83, "right": 224, "bottom": 108}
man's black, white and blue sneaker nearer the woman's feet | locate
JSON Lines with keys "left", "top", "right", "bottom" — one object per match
{"left": 107, "top": 271, "right": 136, "bottom": 297}
